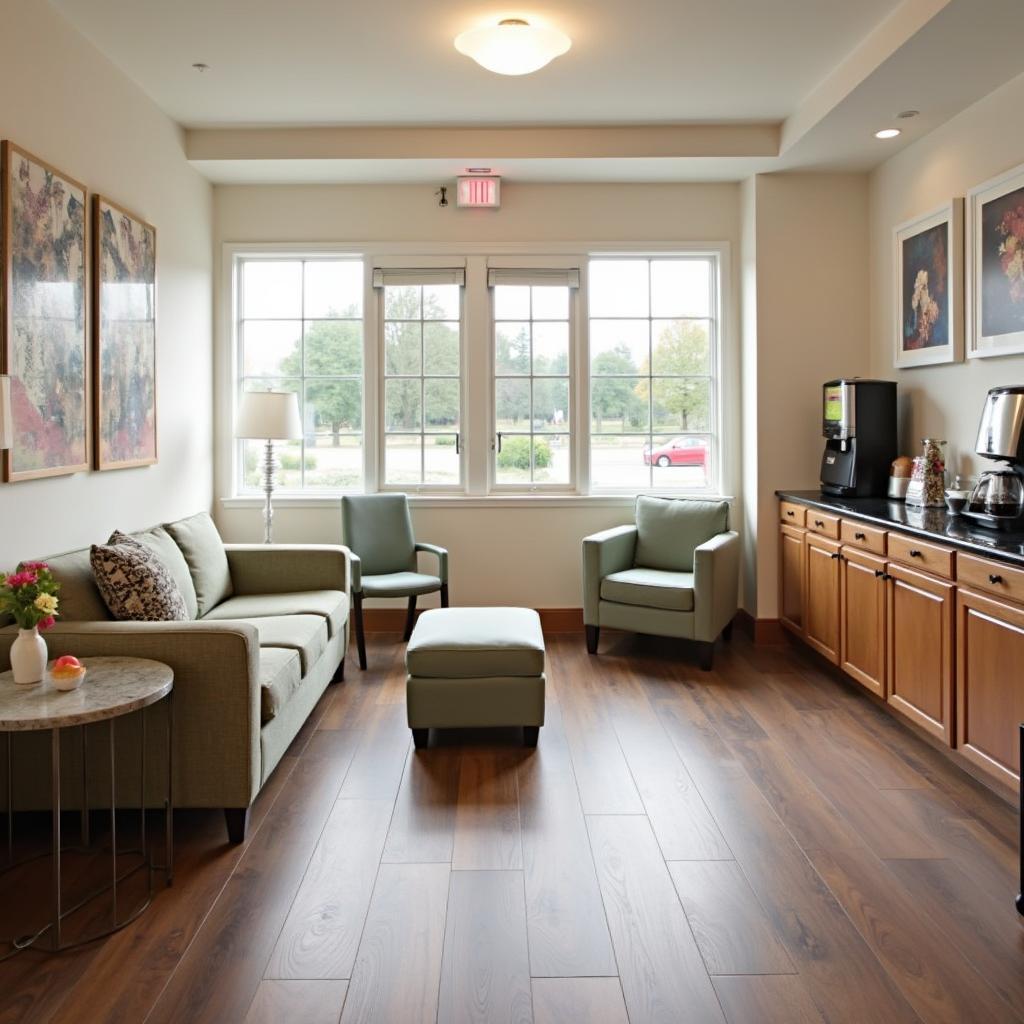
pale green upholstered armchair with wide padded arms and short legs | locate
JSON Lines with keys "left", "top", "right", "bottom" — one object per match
{"left": 583, "top": 496, "right": 739, "bottom": 670}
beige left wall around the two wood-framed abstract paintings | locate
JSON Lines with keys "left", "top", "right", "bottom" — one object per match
{"left": 0, "top": 0, "right": 213, "bottom": 568}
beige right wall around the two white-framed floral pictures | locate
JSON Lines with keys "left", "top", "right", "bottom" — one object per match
{"left": 870, "top": 76, "right": 1024, "bottom": 473}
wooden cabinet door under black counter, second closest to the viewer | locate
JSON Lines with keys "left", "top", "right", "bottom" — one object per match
{"left": 888, "top": 562, "right": 953, "bottom": 746}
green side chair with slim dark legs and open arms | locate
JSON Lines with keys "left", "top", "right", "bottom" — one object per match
{"left": 341, "top": 495, "right": 447, "bottom": 669}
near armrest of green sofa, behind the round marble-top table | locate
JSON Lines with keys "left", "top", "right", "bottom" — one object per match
{"left": 0, "top": 622, "right": 262, "bottom": 807}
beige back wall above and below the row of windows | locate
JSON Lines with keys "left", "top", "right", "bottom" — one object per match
{"left": 214, "top": 183, "right": 739, "bottom": 608}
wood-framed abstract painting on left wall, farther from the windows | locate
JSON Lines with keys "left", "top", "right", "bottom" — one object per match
{"left": 0, "top": 141, "right": 91, "bottom": 481}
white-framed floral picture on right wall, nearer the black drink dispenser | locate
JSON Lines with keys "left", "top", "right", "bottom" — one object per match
{"left": 894, "top": 199, "right": 964, "bottom": 369}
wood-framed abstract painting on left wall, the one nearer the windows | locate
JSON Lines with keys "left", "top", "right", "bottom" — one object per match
{"left": 93, "top": 196, "right": 157, "bottom": 469}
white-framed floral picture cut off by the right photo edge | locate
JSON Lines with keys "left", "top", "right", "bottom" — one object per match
{"left": 968, "top": 165, "right": 1024, "bottom": 358}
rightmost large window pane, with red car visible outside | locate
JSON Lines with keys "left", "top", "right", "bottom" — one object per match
{"left": 588, "top": 256, "right": 718, "bottom": 490}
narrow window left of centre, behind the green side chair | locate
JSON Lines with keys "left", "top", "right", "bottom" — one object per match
{"left": 374, "top": 270, "right": 464, "bottom": 488}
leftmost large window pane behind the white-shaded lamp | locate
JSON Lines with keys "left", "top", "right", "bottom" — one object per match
{"left": 238, "top": 257, "right": 364, "bottom": 492}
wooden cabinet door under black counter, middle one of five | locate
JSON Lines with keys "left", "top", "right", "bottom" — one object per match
{"left": 840, "top": 546, "right": 886, "bottom": 697}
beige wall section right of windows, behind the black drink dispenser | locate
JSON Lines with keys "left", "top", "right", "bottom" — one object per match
{"left": 743, "top": 174, "right": 868, "bottom": 618}
